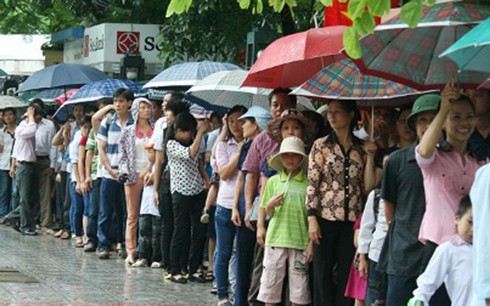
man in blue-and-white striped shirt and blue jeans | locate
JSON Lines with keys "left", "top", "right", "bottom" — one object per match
{"left": 93, "top": 88, "right": 134, "bottom": 259}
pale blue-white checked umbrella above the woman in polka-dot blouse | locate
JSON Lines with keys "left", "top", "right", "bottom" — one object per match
{"left": 143, "top": 61, "right": 240, "bottom": 89}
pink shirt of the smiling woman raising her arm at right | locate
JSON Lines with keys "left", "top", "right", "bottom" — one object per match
{"left": 415, "top": 146, "right": 480, "bottom": 245}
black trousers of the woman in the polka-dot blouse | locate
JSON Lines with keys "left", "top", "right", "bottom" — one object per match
{"left": 170, "top": 192, "right": 206, "bottom": 274}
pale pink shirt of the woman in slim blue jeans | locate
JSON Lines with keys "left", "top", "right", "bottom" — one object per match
{"left": 216, "top": 138, "right": 238, "bottom": 209}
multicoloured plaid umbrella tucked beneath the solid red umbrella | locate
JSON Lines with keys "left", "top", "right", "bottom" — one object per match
{"left": 293, "top": 59, "right": 419, "bottom": 100}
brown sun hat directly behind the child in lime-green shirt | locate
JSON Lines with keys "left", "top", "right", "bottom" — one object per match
{"left": 267, "top": 108, "right": 317, "bottom": 144}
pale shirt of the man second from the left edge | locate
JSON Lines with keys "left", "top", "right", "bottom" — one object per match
{"left": 12, "top": 120, "right": 37, "bottom": 162}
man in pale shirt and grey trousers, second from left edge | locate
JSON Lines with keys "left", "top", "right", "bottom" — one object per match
{"left": 13, "top": 103, "right": 43, "bottom": 236}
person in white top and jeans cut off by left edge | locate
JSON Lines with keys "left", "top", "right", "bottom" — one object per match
{"left": 0, "top": 108, "right": 17, "bottom": 224}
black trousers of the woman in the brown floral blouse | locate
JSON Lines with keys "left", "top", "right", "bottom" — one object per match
{"left": 313, "top": 217, "right": 355, "bottom": 306}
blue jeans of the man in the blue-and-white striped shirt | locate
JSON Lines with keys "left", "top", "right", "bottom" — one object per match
{"left": 99, "top": 178, "right": 126, "bottom": 250}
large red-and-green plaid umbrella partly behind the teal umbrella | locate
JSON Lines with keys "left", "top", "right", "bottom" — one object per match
{"left": 355, "top": 2, "right": 490, "bottom": 90}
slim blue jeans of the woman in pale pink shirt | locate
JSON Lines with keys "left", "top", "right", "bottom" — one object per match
{"left": 214, "top": 204, "right": 236, "bottom": 300}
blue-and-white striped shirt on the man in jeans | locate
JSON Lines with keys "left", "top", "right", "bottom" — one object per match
{"left": 97, "top": 114, "right": 134, "bottom": 180}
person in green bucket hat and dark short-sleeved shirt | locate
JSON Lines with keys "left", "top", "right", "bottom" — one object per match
{"left": 377, "top": 94, "right": 441, "bottom": 305}
